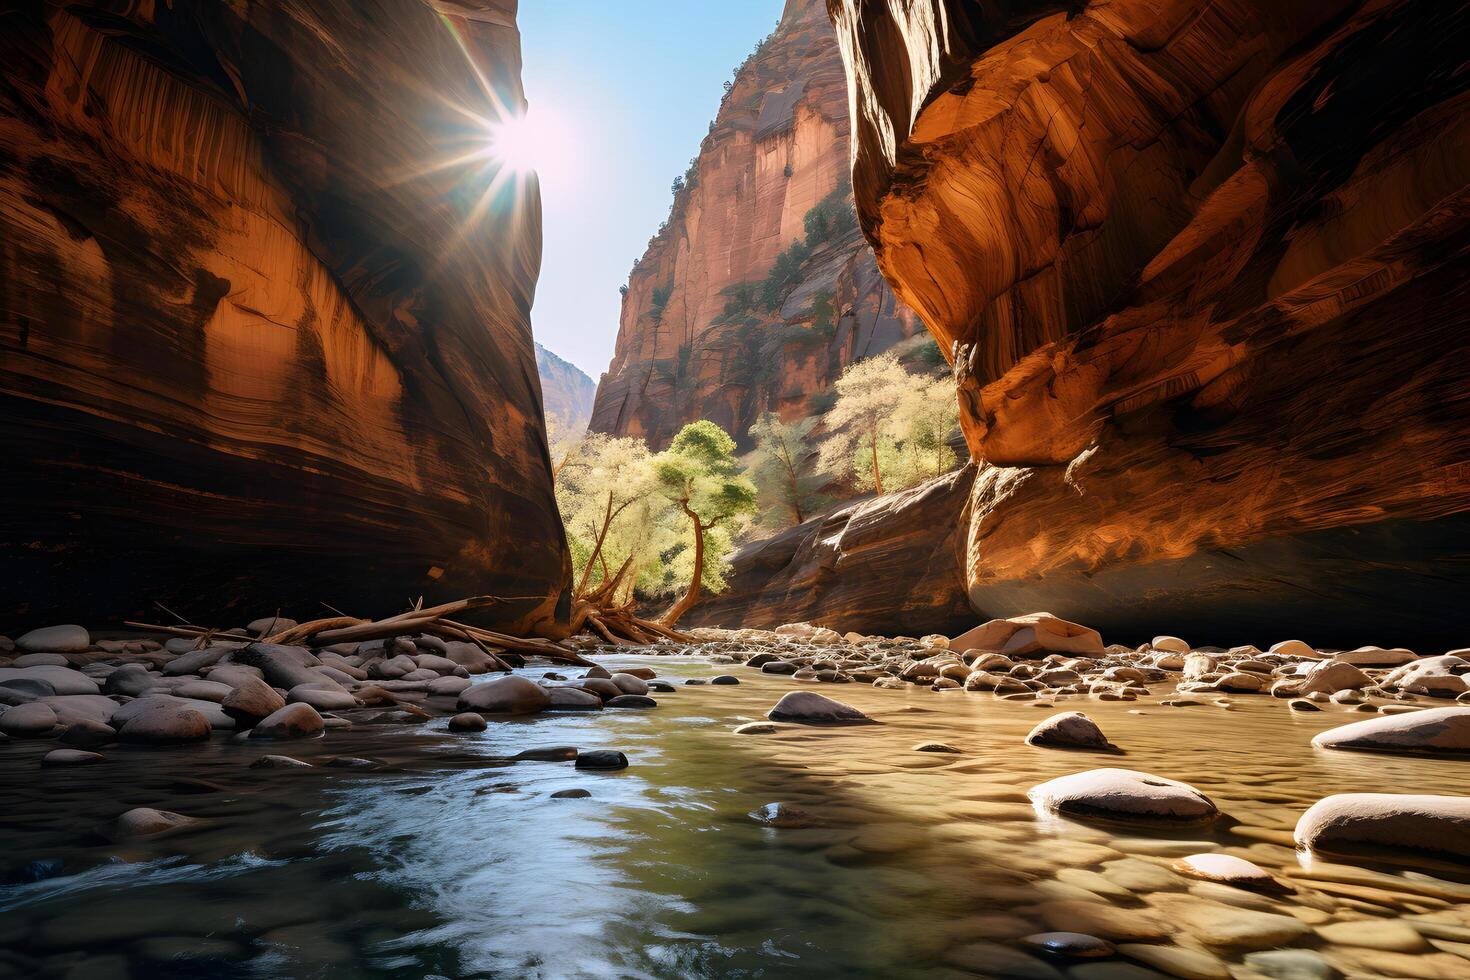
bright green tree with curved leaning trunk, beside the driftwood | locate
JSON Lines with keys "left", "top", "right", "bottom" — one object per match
{"left": 654, "top": 419, "right": 756, "bottom": 626}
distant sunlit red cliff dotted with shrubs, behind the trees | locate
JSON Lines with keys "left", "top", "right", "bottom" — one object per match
{"left": 592, "top": 0, "right": 922, "bottom": 448}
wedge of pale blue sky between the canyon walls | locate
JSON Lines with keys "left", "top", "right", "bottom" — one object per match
{"left": 517, "top": 0, "right": 784, "bottom": 381}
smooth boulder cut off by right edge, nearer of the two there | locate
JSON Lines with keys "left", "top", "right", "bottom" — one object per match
{"left": 1294, "top": 793, "right": 1470, "bottom": 862}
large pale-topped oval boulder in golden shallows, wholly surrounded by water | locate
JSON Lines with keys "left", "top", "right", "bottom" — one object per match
{"left": 1029, "top": 768, "right": 1219, "bottom": 823}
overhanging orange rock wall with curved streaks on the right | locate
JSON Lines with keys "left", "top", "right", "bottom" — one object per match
{"left": 829, "top": 0, "right": 1470, "bottom": 645}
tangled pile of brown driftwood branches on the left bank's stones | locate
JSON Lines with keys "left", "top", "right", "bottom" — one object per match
{"left": 126, "top": 595, "right": 592, "bottom": 670}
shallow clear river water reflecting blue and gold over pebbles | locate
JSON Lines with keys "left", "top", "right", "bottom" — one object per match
{"left": 0, "top": 657, "right": 1470, "bottom": 980}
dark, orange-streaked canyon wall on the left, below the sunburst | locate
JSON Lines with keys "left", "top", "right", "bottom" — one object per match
{"left": 0, "top": 0, "right": 567, "bottom": 630}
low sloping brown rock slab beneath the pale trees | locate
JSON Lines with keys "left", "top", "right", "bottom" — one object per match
{"left": 681, "top": 466, "right": 975, "bottom": 636}
